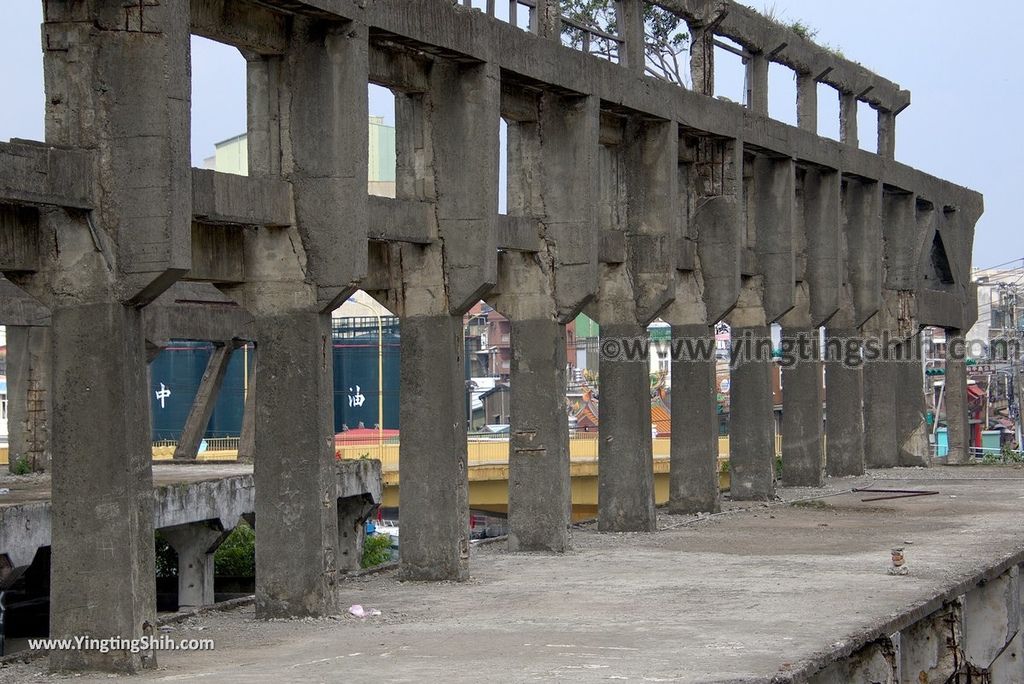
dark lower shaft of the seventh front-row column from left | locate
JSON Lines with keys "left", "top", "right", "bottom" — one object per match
{"left": 729, "top": 326, "right": 775, "bottom": 501}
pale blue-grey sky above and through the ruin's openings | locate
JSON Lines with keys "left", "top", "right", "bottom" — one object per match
{"left": 0, "top": 0, "right": 1024, "bottom": 267}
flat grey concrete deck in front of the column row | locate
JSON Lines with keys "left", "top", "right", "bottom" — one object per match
{"left": 0, "top": 466, "right": 1024, "bottom": 682}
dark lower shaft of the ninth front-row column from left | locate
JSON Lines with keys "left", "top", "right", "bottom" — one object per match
{"left": 823, "top": 329, "right": 864, "bottom": 477}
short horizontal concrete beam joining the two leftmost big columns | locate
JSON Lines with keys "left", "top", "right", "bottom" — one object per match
{"left": 193, "top": 169, "right": 295, "bottom": 227}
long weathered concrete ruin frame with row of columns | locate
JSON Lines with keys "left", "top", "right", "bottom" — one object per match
{"left": 0, "top": 0, "right": 983, "bottom": 681}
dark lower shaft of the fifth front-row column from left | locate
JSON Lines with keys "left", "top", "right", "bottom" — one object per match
{"left": 597, "top": 324, "right": 656, "bottom": 532}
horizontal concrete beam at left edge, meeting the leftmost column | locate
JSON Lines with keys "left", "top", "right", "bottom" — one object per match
{"left": 0, "top": 140, "right": 95, "bottom": 209}
